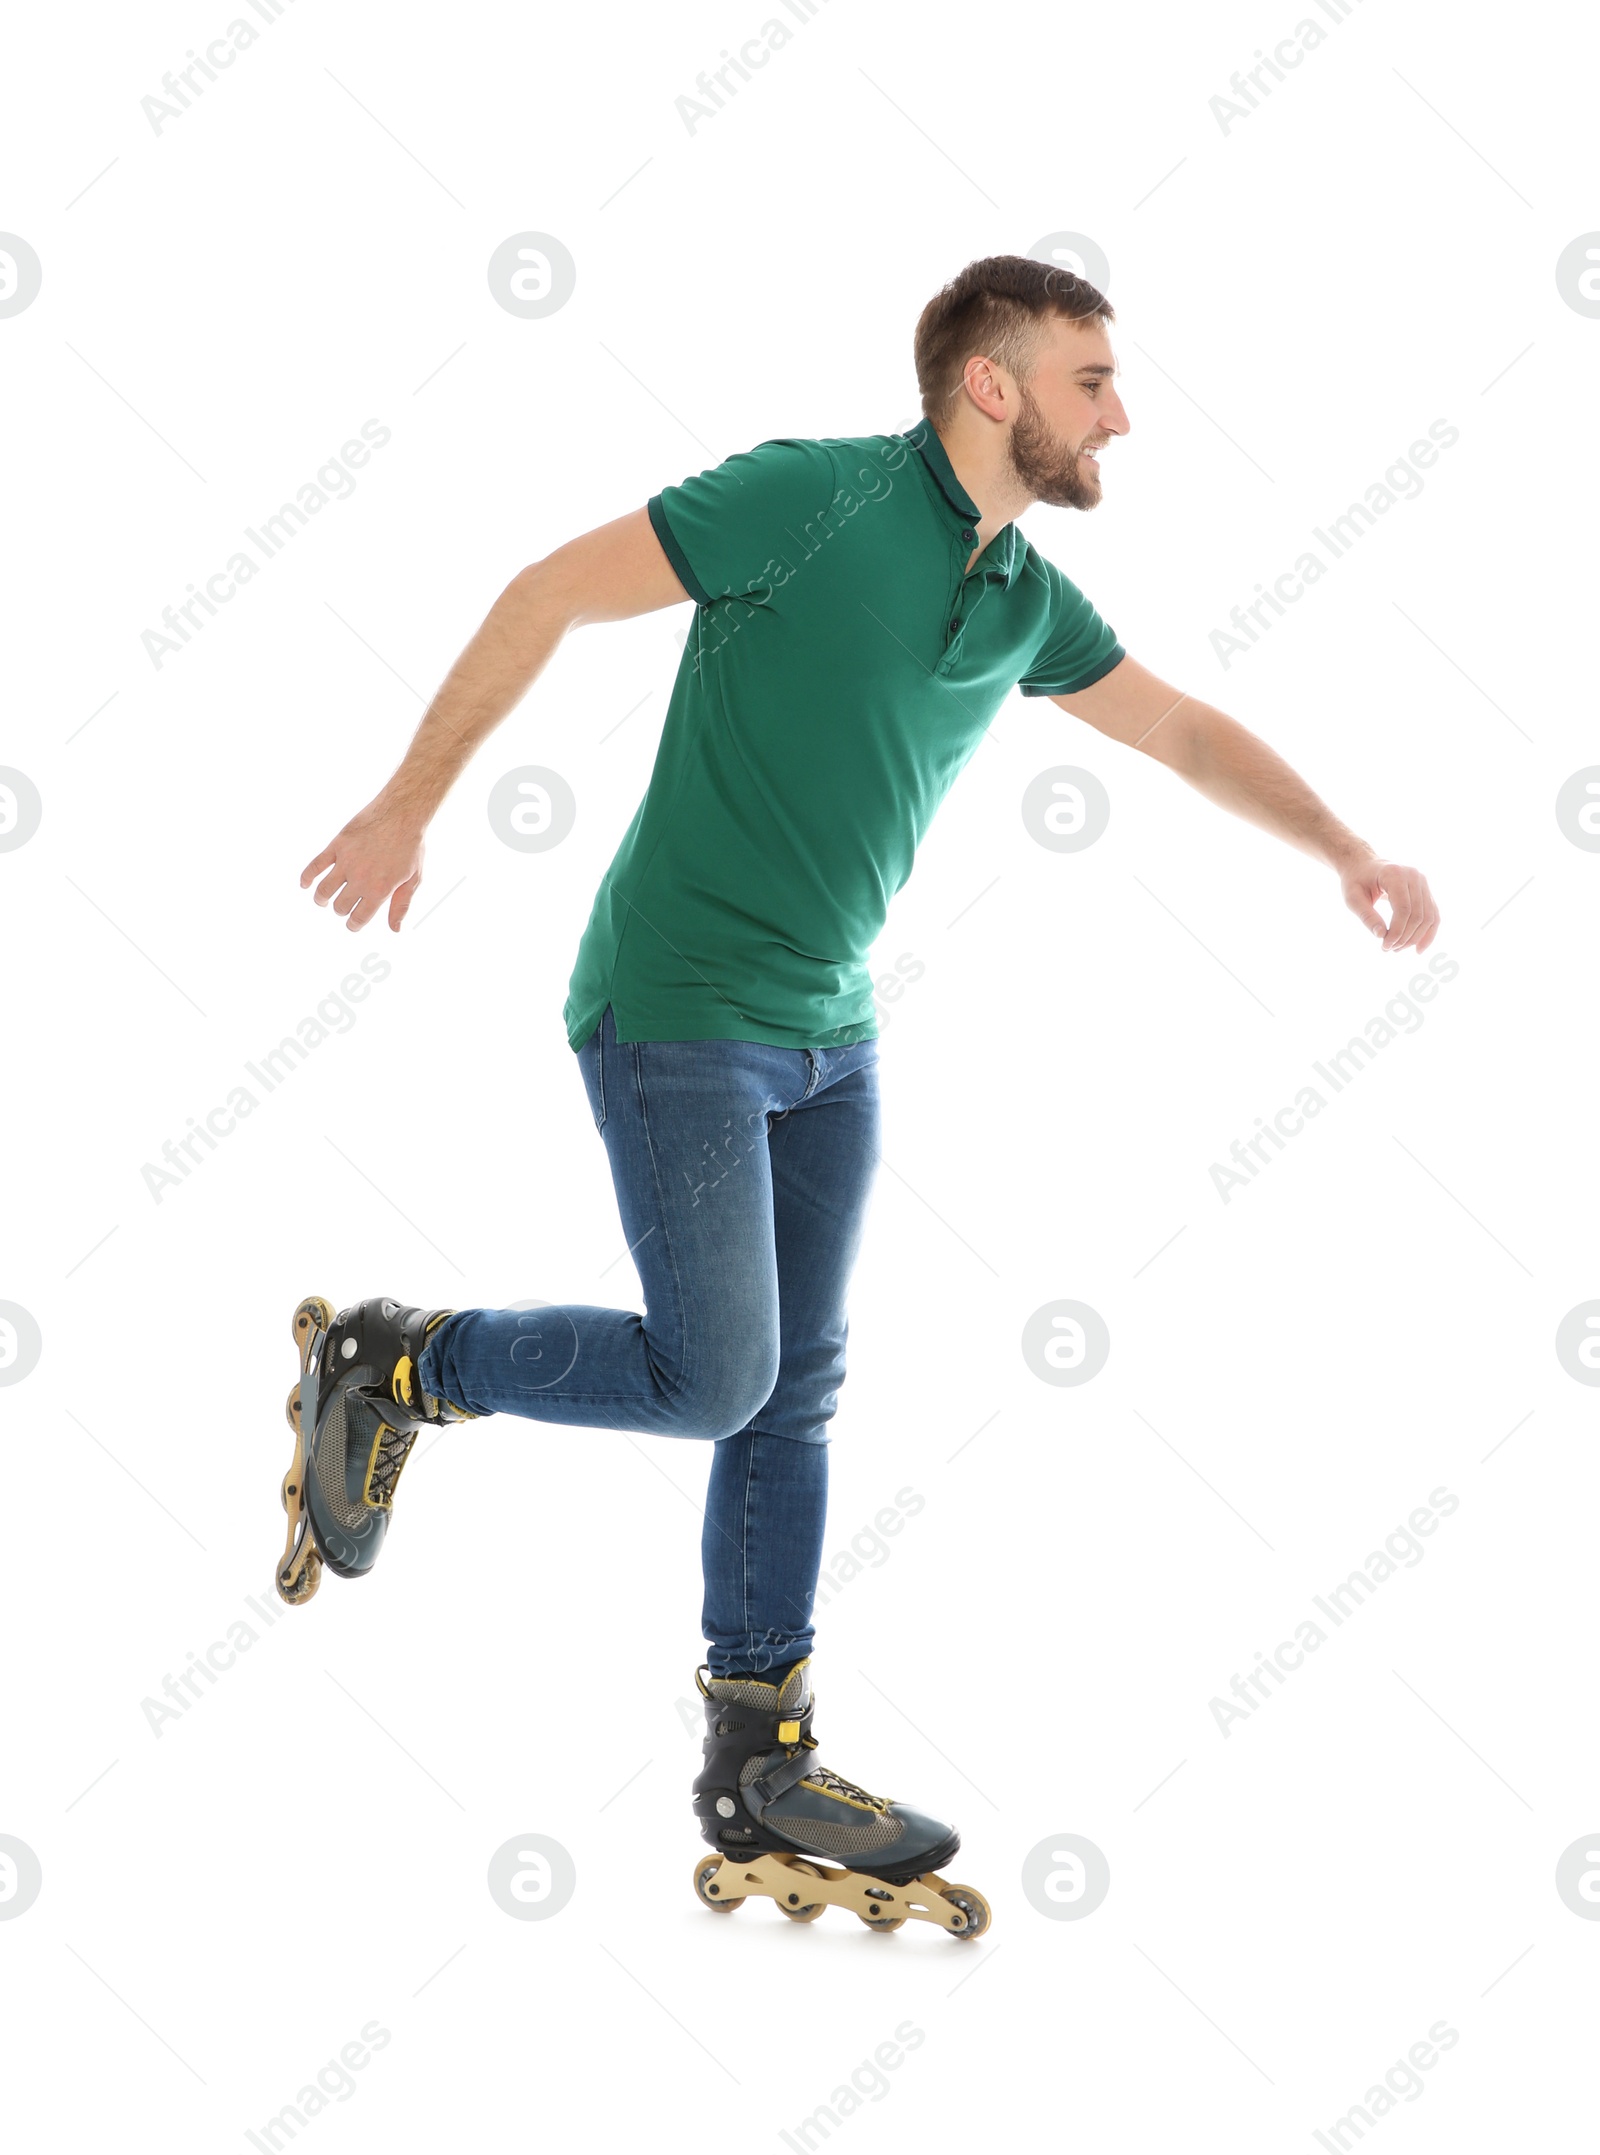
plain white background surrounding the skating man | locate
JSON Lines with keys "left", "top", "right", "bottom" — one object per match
{"left": 0, "top": 0, "right": 1600, "bottom": 2151}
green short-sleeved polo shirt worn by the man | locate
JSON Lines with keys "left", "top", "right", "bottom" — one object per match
{"left": 563, "top": 420, "right": 1123, "bottom": 1047}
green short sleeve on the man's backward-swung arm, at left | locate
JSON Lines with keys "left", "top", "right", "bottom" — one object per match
{"left": 647, "top": 440, "right": 837, "bottom": 606}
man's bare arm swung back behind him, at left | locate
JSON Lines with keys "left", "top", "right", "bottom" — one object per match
{"left": 300, "top": 509, "right": 688, "bottom": 929}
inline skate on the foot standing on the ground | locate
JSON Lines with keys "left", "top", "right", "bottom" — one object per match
{"left": 694, "top": 1659, "right": 990, "bottom": 1937}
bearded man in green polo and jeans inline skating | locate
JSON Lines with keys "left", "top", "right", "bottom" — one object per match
{"left": 278, "top": 254, "right": 1438, "bottom": 1937}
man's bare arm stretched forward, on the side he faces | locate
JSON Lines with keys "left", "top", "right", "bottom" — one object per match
{"left": 1050, "top": 657, "right": 1438, "bottom": 950}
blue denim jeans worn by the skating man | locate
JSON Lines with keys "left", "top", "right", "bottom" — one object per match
{"left": 418, "top": 1011, "right": 880, "bottom": 1677}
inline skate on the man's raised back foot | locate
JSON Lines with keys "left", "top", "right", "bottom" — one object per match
{"left": 274, "top": 1295, "right": 472, "bottom": 1605}
